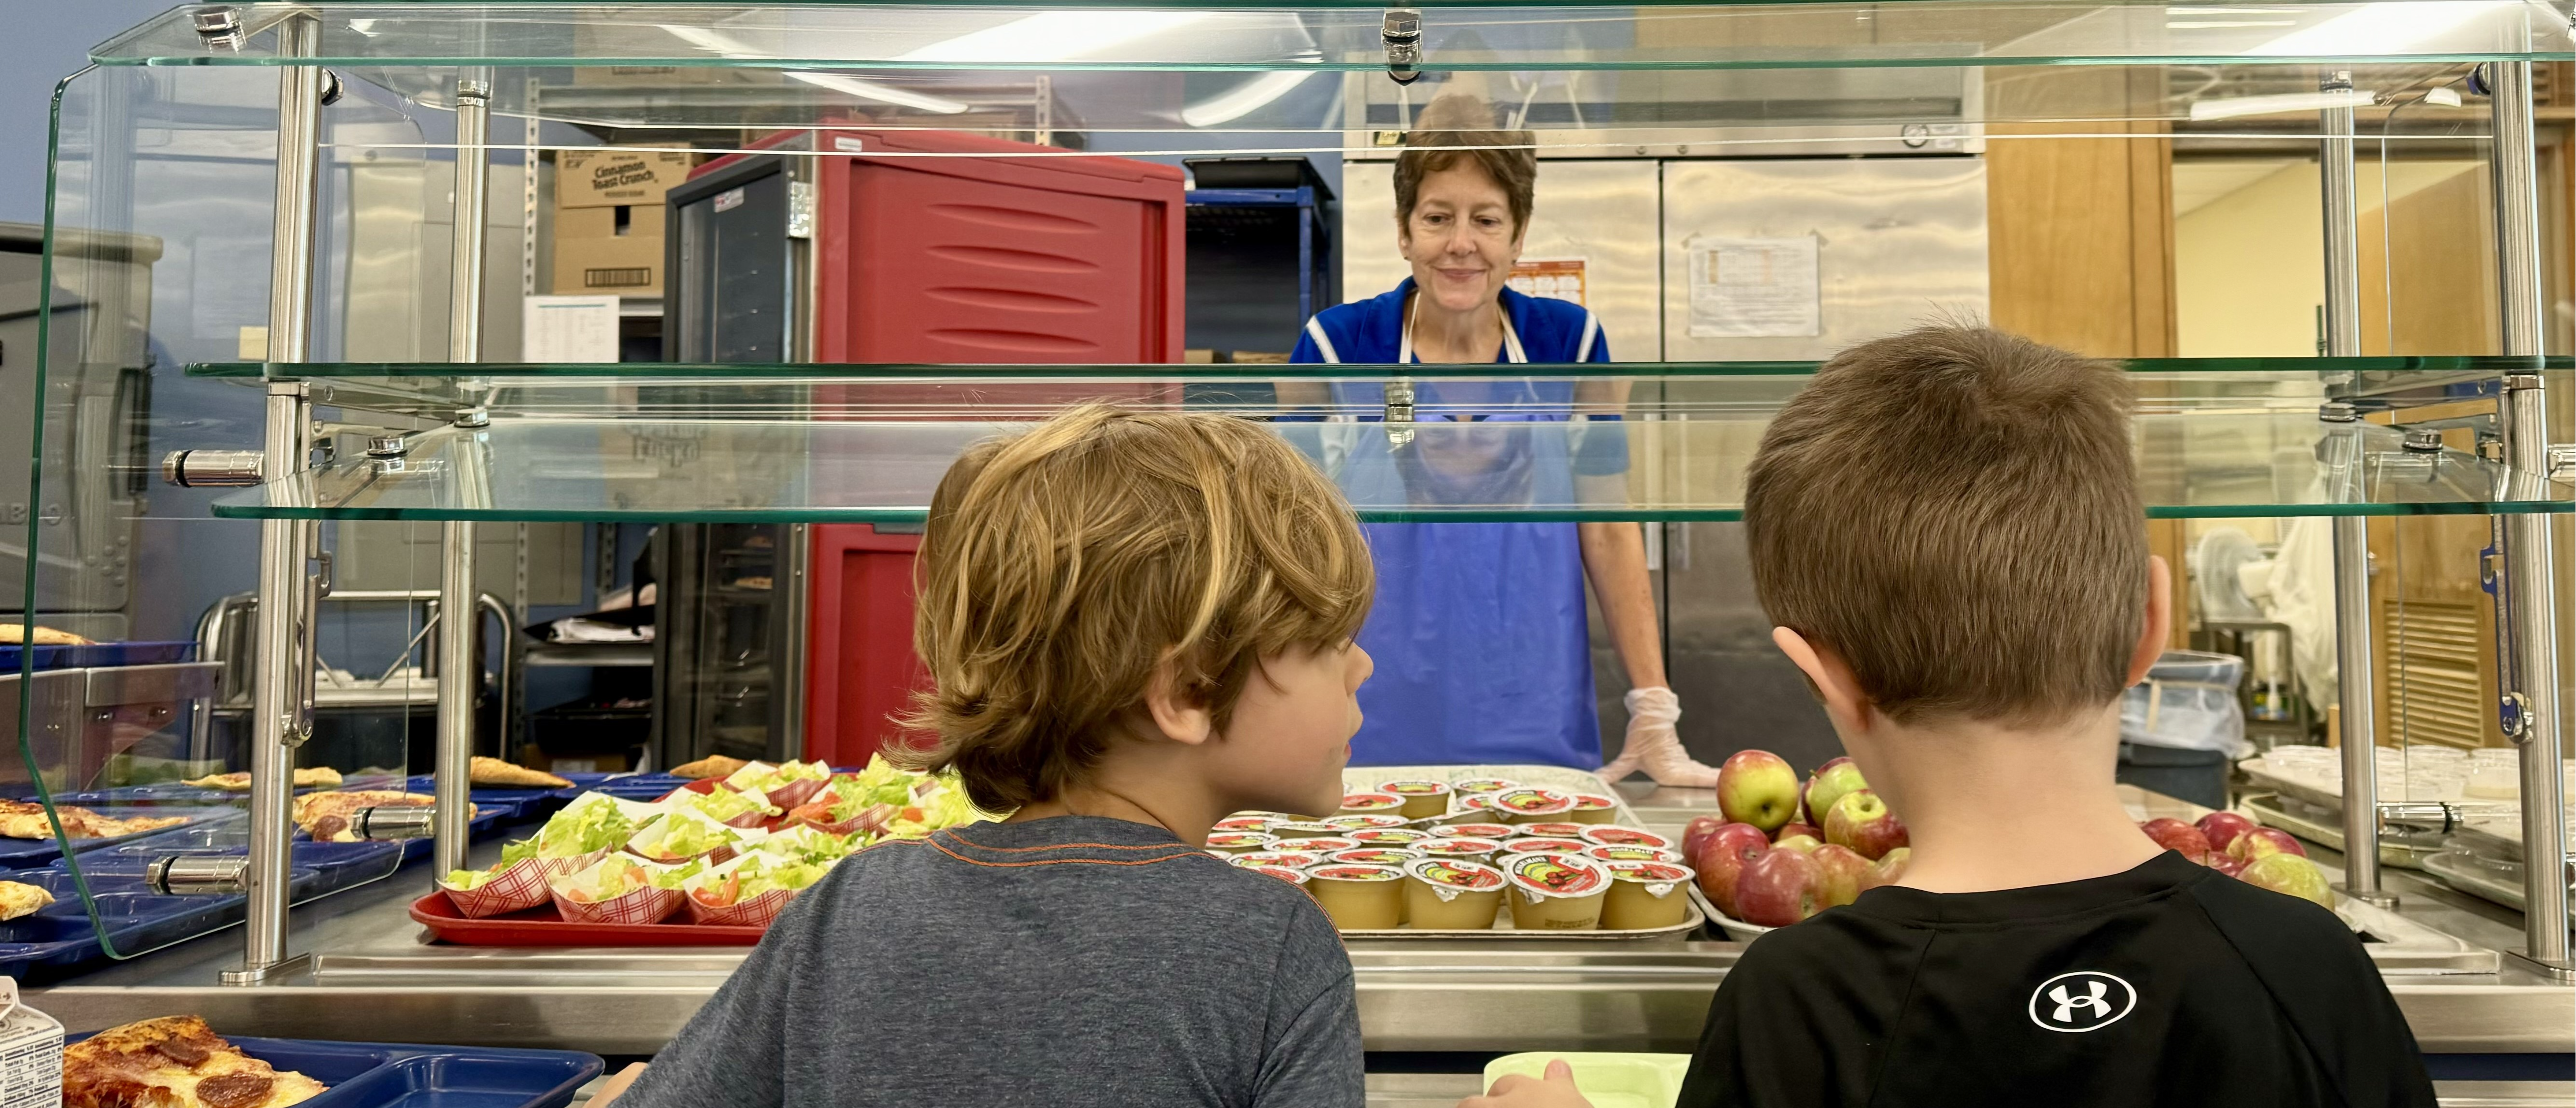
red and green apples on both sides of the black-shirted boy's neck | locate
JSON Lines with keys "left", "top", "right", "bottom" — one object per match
{"left": 1682, "top": 750, "right": 2334, "bottom": 940}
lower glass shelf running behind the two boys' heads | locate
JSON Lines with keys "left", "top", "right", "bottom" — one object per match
{"left": 214, "top": 361, "right": 2576, "bottom": 523}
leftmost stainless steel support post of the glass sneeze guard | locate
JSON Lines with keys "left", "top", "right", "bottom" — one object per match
{"left": 222, "top": 13, "right": 322, "bottom": 984}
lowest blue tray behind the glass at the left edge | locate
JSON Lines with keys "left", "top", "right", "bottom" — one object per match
{"left": 0, "top": 868, "right": 312, "bottom": 977}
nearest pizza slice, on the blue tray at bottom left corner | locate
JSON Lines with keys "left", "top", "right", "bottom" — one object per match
{"left": 62, "top": 1015, "right": 327, "bottom": 1108}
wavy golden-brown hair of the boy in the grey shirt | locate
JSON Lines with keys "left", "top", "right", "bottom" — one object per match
{"left": 889, "top": 405, "right": 1376, "bottom": 811}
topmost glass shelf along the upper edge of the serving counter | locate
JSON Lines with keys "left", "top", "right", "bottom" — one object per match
{"left": 93, "top": 0, "right": 2568, "bottom": 75}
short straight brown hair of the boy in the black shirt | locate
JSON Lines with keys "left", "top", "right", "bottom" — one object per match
{"left": 1744, "top": 327, "right": 2149, "bottom": 726}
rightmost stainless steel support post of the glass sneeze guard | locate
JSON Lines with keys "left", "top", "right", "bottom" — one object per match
{"left": 2486, "top": 62, "right": 2576, "bottom": 977}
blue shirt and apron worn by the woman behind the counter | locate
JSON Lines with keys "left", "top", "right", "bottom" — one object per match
{"left": 1288, "top": 278, "right": 1628, "bottom": 768}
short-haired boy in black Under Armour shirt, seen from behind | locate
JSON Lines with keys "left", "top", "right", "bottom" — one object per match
{"left": 1471, "top": 327, "right": 2434, "bottom": 1108}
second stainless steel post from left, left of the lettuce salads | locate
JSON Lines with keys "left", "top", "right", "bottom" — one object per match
{"left": 433, "top": 77, "right": 492, "bottom": 874}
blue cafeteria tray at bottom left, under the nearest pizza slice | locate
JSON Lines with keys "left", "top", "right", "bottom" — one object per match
{"left": 62, "top": 1028, "right": 605, "bottom": 1108}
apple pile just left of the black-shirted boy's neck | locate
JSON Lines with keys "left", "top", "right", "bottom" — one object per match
{"left": 1682, "top": 750, "right": 1914, "bottom": 928}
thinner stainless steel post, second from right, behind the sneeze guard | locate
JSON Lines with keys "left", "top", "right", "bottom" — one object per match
{"left": 2316, "top": 70, "right": 2396, "bottom": 905}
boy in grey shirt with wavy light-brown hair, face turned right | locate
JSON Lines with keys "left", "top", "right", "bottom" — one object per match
{"left": 618, "top": 407, "right": 1373, "bottom": 1108}
